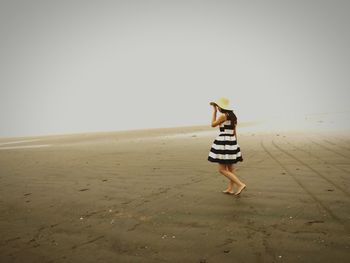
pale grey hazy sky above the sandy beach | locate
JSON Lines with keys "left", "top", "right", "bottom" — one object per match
{"left": 0, "top": 0, "right": 350, "bottom": 136}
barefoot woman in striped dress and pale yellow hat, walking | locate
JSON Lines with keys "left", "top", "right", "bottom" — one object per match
{"left": 208, "top": 98, "right": 246, "bottom": 195}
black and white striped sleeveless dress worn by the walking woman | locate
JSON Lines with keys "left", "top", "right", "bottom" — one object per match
{"left": 208, "top": 116, "right": 243, "bottom": 164}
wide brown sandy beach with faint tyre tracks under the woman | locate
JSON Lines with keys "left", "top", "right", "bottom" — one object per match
{"left": 0, "top": 127, "right": 350, "bottom": 263}
